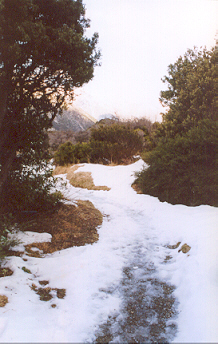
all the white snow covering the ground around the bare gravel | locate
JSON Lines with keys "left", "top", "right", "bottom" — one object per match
{"left": 0, "top": 160, "right": 218, "bottom": 343}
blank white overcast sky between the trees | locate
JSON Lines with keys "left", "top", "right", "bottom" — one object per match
{"left": 75, "top": 0, "right": 218, "bottom": 121}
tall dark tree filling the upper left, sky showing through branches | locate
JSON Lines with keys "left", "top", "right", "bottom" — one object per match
{"left": 0, "top": 0, "right": 100, "bottom": 200}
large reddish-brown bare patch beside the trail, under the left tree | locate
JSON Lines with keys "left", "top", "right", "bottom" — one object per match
{"left": 15, "top": 201, "right": 103, "bottom": 257}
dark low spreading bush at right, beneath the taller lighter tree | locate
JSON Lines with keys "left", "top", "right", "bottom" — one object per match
{"left": 137, "top": 120, "right": 218, "bottom": 205}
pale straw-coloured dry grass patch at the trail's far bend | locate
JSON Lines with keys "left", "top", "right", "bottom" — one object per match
{"left": 53, "top": 165, "right": 110, "bottom": 191}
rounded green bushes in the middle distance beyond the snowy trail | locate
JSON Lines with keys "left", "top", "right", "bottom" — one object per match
{"left": 54, "top": 124, "right": 143, "bottom": 165}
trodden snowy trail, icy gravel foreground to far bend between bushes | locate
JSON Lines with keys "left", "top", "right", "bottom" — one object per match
{"left": 55, "top": 162, "right": 181, "bottom": 343}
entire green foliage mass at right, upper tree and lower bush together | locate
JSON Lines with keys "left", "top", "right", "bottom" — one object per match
{"left": 136, "top": 50, "right": 218, "bottom": 206}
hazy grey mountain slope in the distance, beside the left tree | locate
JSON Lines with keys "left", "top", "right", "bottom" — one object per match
{"left": 53, "top": 107, "right": 97, "bottom": 132}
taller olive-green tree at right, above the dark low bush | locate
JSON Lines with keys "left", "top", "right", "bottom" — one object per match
{"left": 159, "top": 48, "right": 218, "bottom": 138}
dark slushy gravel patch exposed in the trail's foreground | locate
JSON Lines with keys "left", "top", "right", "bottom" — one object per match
{"left": 94, "top": 261, "right": 178, "bottom": 343}
